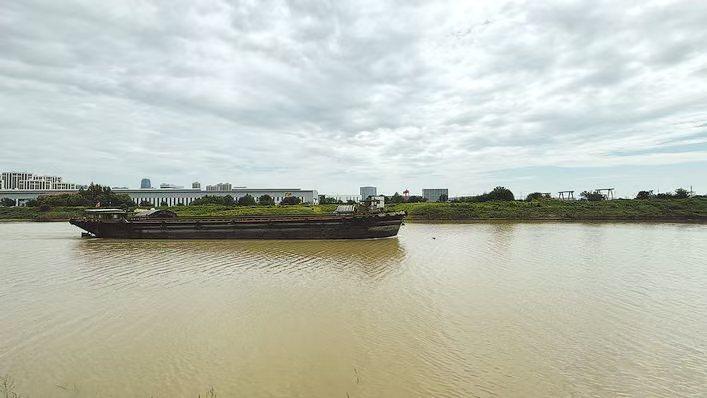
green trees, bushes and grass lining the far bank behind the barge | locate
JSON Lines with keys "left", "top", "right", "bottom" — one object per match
{"left": 0, "top": 184, "right": 707, "bottom": 221}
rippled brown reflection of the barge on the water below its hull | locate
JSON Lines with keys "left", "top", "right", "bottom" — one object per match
{"left": 76, "top": 239, "right": 405, "bottom": 278}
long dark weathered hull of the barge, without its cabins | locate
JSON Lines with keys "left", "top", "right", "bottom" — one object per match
{"left": 69, "top": 213, "right": 405, "bottom": 239}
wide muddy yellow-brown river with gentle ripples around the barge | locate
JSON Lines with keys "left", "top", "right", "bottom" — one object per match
{"left": 0, "top": 223, "right": 707, "bottom": 398}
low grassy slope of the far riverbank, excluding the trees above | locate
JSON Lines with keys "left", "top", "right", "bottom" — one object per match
{"left": 0, "top": 198, "right": 707, "bottom": 222}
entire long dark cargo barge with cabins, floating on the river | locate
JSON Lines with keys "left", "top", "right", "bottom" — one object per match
{"left": 69, "top": 198, "right": 405, "bottom": 239}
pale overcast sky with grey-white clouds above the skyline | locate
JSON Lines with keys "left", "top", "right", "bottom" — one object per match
{"left": 0, "top": 0, "right": 707, "bottom": 196}
